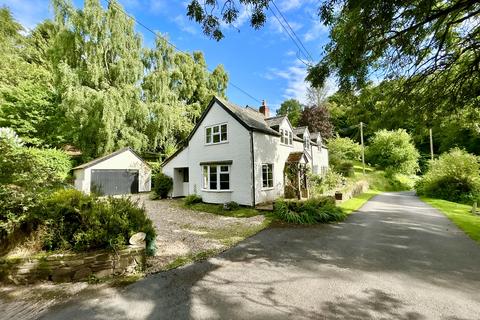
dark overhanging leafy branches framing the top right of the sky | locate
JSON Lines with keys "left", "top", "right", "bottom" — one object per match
{"left": 187, "top": 0, "right": 480, "bottom": 114}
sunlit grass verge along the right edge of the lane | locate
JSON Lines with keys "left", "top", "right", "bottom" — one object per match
{"left": 420, "top": 197, "right": 480, "bottom": 243}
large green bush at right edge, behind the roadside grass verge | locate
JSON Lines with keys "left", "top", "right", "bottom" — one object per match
{"left": 415, "top": 148, "right": 480, "bottom": 204}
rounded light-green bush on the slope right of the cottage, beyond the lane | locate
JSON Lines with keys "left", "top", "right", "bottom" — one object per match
{"left": 365, "top": 129, "right": 420, "bottom": 174}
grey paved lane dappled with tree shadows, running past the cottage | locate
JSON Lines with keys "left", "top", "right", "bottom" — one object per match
{"left": 40, "top": 193, "right": 480, "bottom": 320}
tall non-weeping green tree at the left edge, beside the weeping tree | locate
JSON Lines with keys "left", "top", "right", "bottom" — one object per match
{"left": 0, "top": 8, "right": 62, "bottom": 146}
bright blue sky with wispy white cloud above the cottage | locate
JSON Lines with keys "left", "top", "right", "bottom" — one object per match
{"left": 0, "top": 0, "right": 335, "bottom": 110}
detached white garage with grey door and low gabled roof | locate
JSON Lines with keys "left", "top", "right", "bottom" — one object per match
{"left": 73, "top": 147, "right": 152, "bottom": 195}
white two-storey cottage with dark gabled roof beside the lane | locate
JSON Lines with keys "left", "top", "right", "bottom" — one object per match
{"left": 162, "top": 97, "right": 328, "bottom": 206}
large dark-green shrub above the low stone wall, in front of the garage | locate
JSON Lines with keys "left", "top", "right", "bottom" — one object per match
{"left": 36, "top": 189, "right": 155, "bottom": 255}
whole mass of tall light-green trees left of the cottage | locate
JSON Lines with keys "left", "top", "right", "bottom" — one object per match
{"left": 0, "top": 0, "right": 228, "bottom": 160}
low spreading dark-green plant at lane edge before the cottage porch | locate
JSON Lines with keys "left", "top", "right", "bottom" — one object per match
{"left": 273, "top": 197, "right": 345, "bottom": 224}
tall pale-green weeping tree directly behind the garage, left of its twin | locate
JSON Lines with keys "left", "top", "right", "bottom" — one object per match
{"left": 53, "top": 0, "right": 148, "bottom": 158}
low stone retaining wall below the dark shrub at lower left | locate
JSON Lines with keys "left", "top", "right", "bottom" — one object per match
{"left": 0, "top": 246, "right": 145, "bottom": 283}
